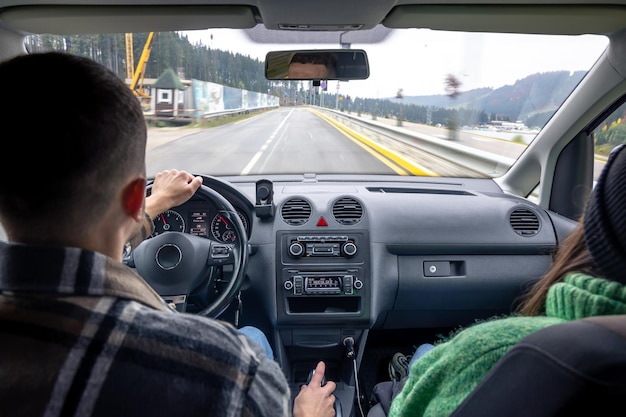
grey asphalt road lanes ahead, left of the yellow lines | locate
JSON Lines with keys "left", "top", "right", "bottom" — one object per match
{"left": 146, "top": 108, "right": 395, "bottom": 176}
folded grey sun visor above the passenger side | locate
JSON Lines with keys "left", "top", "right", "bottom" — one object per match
{"left": 383, "top": 3, "right": 626, "bottom": 35}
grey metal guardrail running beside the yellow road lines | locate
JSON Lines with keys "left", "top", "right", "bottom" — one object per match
{"left": 314, "top": 106, "right": 515, "bottom": 177}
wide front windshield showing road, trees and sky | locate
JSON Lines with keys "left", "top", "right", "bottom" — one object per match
{"left": 27, "top": 28, "right": 607, "bottom": 177}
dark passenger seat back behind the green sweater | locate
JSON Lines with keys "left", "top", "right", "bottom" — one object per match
{"left": 452, "top": 315, "right": 626, "bottom": 417}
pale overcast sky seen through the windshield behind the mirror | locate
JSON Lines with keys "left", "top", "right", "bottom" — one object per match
{"left": 183, "top": 29, "right": 608, "bottom": 98}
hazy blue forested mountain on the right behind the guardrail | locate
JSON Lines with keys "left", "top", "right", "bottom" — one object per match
{"left": 404, "top": 71, "right": 585, "bottom": 126}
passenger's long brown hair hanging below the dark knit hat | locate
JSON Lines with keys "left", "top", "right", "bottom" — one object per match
{"left": 517, "top": 219, "right": 600, "bottom": 316}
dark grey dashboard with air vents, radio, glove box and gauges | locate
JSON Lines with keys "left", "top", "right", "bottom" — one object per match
{"left": 143, "top": 176, "right": 576, "bottom": 412}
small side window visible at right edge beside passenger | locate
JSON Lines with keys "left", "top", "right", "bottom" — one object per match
{"left": 593, "top": 102, "right": 626, "bottom": 181}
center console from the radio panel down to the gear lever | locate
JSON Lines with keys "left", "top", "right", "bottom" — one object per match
{"left": 276, "top": 230, "right": 371, "bottom": 416}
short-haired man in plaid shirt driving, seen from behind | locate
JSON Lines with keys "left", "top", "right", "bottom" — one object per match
{"left": 0, "top": 53, "right": 335, "bottom": 417}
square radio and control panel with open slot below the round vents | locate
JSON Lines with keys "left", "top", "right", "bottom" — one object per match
{"left": 277, "top": 231, "right": 370, "bottom": 320}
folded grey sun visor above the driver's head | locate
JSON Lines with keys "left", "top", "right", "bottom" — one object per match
{"left": 0, "top": 5, "right": 257, "bottom": 35}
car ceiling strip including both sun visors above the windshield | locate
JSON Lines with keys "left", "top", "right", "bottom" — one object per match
{"left": 0, "top": 0, "right": 626, "bottom": 36}
